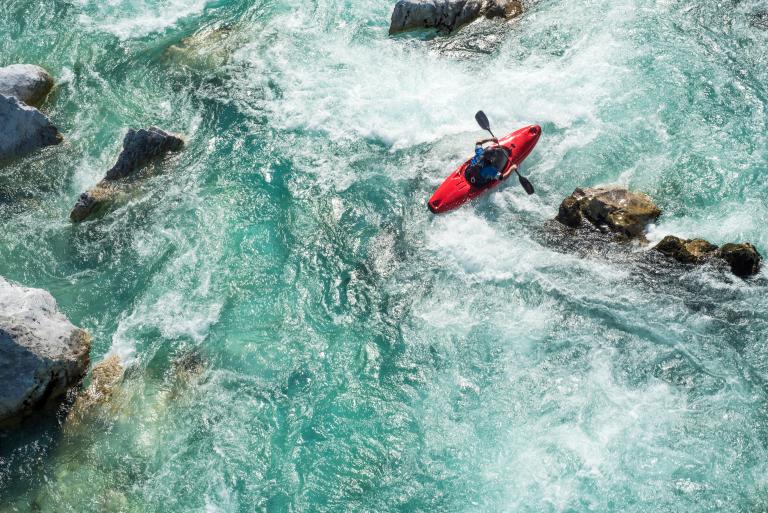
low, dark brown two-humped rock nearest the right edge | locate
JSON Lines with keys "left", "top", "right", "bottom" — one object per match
{"left": 653, "top": 235, "right": 762, "bottom": 277}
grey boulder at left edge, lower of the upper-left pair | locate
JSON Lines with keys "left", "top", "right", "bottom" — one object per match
{"left": 0, "top": 94, "right": 62, "bottom": 161}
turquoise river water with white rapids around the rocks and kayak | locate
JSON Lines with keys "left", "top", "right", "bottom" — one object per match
{"left": 0, "top": 0, "right": 768, "bottom": 512}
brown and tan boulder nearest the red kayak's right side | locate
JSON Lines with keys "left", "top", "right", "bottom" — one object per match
{"left": 557, "top": 187, "right": 661, "bottom": 240}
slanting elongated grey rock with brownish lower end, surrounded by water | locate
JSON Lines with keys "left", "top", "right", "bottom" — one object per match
{"left": 69, "top": 127, "right": 184, "bottom": 222}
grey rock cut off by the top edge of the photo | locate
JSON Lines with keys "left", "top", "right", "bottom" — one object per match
{"left": 389, "top": 0, "right": 523, "bottom": 34}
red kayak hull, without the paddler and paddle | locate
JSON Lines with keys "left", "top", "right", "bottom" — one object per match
{"left": 427, "top": 125, "right": 541, "bottom": 214}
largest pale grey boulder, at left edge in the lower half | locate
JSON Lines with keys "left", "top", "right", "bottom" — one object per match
{"left": 0, "top": 278, "right": 91, "bottom": 423}
